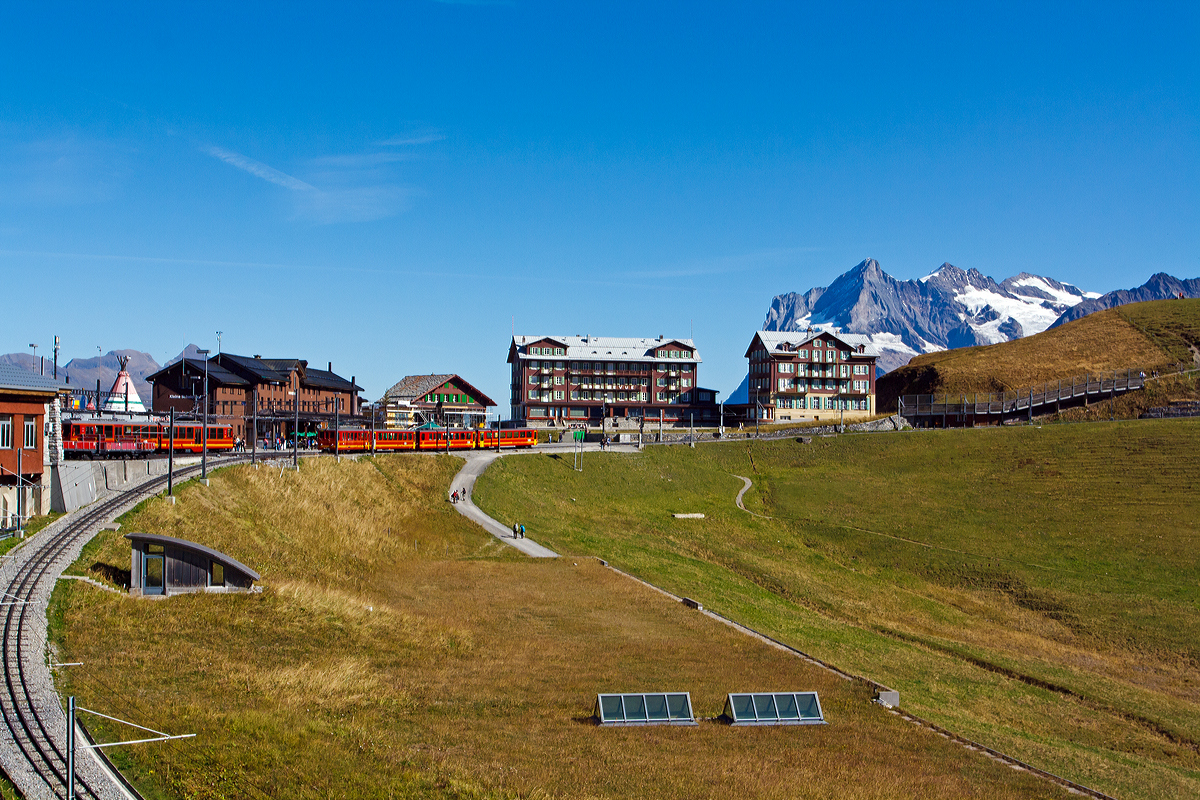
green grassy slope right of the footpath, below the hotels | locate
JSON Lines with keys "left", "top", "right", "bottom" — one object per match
{"left": 475, "top": 421, "right": 1200, "bottom": 800}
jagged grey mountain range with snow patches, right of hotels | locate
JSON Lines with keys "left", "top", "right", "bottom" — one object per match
{"left": 763, "top": 258, "right": 1200, "bottom": 372}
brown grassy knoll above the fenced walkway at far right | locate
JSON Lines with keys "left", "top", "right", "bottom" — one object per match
{"left": 877, "top": 300, "right": 1200, "bottom": 409}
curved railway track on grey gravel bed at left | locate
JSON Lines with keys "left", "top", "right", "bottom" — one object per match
{"left": 0, "top": 453, "right": 276, "bottom": 800}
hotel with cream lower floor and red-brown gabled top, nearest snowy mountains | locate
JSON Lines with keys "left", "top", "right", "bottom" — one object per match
{"left": 744, "top": 329, "right": 880, "bottom": 422}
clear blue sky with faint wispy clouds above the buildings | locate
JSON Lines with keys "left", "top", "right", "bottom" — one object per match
{"left": 0, "top": 0, "right": 1200, "bottom": 407}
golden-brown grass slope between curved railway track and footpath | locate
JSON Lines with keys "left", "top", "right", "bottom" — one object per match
{"left": 52, "top": 456, "right": 1066, "bottom": 800}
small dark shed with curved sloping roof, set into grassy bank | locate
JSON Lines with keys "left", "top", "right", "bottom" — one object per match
{"left": 125, "top": 533, "right": 262, "bottom": 596}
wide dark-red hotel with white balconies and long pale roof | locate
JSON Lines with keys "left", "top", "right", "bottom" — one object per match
{"left": 509, "top": 336, "right": 719, "bottom": 427}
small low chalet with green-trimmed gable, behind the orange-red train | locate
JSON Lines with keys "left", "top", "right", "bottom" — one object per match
{"left": 374, "top": 374, "right": 496, "bottom": 429}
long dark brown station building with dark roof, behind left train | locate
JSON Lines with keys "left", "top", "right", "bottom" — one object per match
{"left": 146, "top": 353, "right": 362, "bottom": 440}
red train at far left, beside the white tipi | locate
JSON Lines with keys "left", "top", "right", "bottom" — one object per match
{"left": 62, "top": 420, "right": 233, "bottom": 458}
